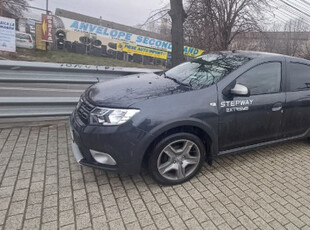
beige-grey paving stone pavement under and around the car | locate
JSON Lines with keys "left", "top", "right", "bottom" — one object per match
{"left": 0, "top": 122, "right": 310, "bottom": 230}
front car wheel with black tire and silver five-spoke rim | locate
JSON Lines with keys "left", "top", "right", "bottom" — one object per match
{"left": 148, "top": 133, "right": 206, "bottom": 185}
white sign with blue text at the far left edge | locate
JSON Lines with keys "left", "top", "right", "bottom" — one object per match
{"left": 0, "top": 17, "right": 16, "bottom": 52}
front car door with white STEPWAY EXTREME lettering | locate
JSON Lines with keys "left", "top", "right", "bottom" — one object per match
{"left": 218, "top": 59, "right": 285, "bottom": 151}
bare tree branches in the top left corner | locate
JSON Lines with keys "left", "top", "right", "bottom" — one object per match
{"left": 2, "top": 0, "right": 29, "bottom": 18}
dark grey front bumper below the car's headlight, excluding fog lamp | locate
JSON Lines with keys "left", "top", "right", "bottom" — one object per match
{"left": 70, "top": 112, "right": 146, "bottom": 174}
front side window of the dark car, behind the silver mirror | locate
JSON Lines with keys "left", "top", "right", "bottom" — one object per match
{"left": 237, "top": 62, "right": 282, "bottom": 95}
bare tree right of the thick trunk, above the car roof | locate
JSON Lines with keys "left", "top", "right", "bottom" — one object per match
{"left": 186, "top": 0, "right": 268, "bottom": 50}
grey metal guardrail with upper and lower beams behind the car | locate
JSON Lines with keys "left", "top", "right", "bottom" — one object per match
{"left": 0, "top": 60, "right": 162, "bottom": 118}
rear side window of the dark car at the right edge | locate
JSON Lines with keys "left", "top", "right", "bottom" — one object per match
{"left": 289, "top": 63, "right": 310, "bottom": 91}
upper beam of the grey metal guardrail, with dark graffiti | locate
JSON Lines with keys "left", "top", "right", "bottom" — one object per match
{"left": 0, "top": 60, "right": 162, "bottom": 84}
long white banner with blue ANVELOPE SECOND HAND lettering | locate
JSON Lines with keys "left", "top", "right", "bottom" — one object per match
{"left": 59, "top": 17, "right": 204, "bottom": 57}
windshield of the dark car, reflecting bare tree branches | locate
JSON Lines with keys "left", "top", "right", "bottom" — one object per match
{"left": 165, "top": 54, "right": 251, "bottom": 88}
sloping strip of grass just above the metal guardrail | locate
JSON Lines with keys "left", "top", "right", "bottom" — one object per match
{"left": 0, "top": 48, "right": 164, "bottom": 69}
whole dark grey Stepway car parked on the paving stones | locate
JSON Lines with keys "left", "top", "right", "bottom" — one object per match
{"left": 71, "top": 51, "right": 310, "bottom": 185}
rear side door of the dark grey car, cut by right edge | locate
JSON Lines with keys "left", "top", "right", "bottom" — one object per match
{"left": 283, "top": 60, "right": 310, "bottom": 137}
